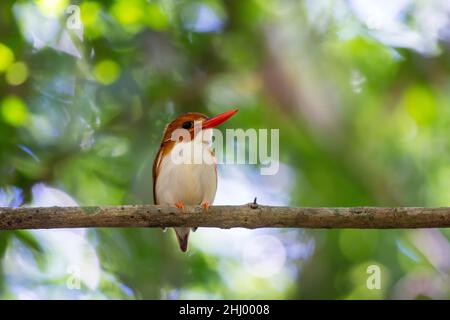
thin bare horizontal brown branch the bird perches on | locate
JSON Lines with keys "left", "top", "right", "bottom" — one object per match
{"left": 0, "top": 204, "right": 450, "bottom": 230}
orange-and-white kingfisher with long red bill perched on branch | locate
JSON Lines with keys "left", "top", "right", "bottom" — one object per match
{"left": 153, "top": 109, "right": 238, "bottom": 252}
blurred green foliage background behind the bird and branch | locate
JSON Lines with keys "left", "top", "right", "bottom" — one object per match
{"left": 0, "top": 0, "right": 450, "bottom": 299}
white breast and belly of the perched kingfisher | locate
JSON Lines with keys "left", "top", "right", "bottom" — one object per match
{"left": 155, "top": 130, "right": 217, "bottom": 206}
